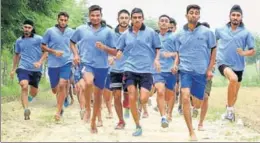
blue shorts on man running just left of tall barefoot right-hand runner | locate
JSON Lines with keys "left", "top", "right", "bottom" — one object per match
{"left": 153, "top": 72, "right": 176, "bottom": 91}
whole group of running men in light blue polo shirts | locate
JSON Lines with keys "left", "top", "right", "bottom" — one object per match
{"left": 11, "top": 5, "right": 255, "bottom": 140}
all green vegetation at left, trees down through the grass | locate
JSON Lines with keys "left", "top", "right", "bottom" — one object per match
{"left": 0, "top": 0, "right": 88, "bottom": 99}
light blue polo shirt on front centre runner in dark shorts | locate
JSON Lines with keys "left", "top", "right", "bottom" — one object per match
{"left": 117, "top": 24, "right": 161, "bottom": 73}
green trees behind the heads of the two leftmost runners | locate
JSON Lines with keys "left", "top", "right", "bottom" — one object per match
{"left": 1, "top": 0, "right": 87, "bottom": 51}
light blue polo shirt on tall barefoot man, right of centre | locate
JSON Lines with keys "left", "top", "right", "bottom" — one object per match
{"left": 176, "top": 24, "right": 216, "bottom": 74}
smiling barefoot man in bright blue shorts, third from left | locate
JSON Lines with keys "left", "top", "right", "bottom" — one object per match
{"left": 71, "top": 5, "right": 117, "bottom": 133}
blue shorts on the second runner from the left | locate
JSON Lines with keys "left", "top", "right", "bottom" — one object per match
{"left": 48, "top": 63, "right": 72, "bottom": 88}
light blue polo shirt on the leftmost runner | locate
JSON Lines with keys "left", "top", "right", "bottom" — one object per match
{"left": 15, "top": 34, "right": 43, "bottom": 71}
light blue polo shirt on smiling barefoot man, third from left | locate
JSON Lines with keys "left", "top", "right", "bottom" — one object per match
{"left": 71, "top": 24, "right": 115, "bottom": 68}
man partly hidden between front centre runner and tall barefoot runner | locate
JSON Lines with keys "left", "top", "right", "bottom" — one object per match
{"left": 153, "top": 15, "right": 177, "bottom": 128}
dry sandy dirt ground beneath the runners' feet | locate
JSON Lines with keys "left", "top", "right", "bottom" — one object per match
{"left": 1, "top": 87, "right": 260, "bottom": 142}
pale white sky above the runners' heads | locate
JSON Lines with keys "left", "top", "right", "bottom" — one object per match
{"left": 88, "top": 0, "right": 260, "bottom": 34}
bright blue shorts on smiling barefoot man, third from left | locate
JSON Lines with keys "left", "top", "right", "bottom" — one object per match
{"left": 82, "top": 64, "right": 108, "bottom": 89}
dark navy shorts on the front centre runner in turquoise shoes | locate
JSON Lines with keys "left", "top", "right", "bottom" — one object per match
{"left": 125, "top": 71, "right": 153, "bottom": 91}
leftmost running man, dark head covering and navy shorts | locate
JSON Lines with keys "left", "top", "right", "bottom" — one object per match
{"left": 10, "top": 20, "right": 47, "bottom": 120}
